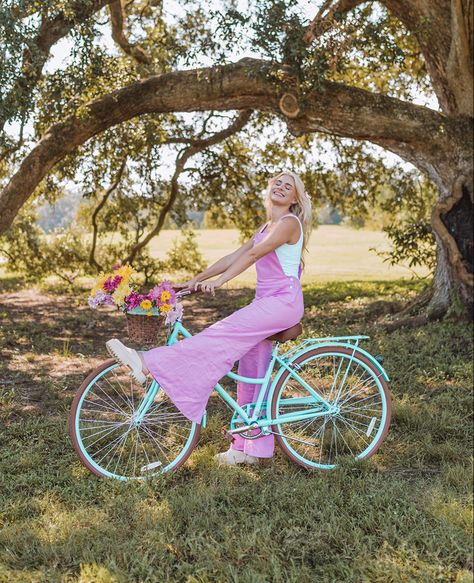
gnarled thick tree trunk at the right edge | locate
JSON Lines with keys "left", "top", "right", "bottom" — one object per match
{"left": 307, "top": 0, "right": 474, "bottom": 317}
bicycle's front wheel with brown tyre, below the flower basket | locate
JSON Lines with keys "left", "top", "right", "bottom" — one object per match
{"left": 69, "top": 359, "right": 200, "bottom": 480}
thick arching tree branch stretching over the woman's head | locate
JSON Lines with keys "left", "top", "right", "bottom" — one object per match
{"left": 0, "top": 59, "right": 466, "bottom": 233}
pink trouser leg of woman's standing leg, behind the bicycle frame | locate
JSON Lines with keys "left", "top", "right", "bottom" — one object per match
{"left": 231, "top": 339, "right": 275, "bottom": 458}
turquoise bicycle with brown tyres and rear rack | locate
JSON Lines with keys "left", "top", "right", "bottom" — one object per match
{"left": 69, "top": 290, "right": 391, "bottom": 480}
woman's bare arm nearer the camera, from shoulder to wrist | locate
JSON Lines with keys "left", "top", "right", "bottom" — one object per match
{"left": 215, "top": 219, "right": 299, "bottom": 286}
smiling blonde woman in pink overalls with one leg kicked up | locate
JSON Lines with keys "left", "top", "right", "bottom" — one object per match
{"left": 106, "top": 172, "right": 312, "bottom": 465}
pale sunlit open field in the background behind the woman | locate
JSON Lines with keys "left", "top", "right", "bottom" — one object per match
{"left": 147, "top": 225, "right": 427, "bottom": 285}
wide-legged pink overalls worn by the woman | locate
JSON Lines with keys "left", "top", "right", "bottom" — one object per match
{"left": 143, "top": 218, "right": 304, "bottom": 457}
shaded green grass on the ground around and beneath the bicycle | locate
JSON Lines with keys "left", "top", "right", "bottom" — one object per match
{"left": 0, "top": 280, "right": 473, "bottom": 583}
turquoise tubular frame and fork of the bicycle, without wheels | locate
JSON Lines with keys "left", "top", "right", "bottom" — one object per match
{"left": 134, "top": 320, "right": 336, "bottom": 433}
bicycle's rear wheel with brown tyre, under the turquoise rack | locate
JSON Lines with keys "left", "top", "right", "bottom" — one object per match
{"left": 270, "top": 346, "right": 391, "bottom": 470}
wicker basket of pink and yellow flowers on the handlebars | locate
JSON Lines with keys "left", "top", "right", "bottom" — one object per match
{"left": 88, "top": 265, "right": 183, "bottom": 345}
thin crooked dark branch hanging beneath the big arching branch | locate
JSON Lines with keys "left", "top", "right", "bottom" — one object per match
{"left": 124, "top": 110, "right": 252, "bottom": 263}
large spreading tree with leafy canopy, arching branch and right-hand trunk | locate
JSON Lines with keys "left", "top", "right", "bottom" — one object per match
{"left": 0, "top": 0, "right": 473, "bottom": 314}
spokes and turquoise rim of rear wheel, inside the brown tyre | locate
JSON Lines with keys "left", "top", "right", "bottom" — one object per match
{"left": 276, "top": 351, "right": 385, "bottom": 467}
